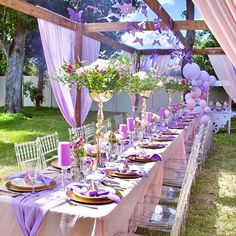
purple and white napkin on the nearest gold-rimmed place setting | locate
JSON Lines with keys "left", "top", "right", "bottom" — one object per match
{"left": 67, "top": 183, "right": 120, "bottom": 204}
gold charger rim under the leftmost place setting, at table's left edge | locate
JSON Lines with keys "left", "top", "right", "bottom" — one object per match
{"left": 5, "top": 180, "right": 57, "bottom": 192}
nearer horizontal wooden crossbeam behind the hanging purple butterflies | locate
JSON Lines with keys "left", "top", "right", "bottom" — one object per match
{"left": 84, "top": 20, "right": 208, "bottom": 33}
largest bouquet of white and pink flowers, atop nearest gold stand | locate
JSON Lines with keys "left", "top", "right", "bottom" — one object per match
{"left": 57, "top": 57, "right": 130, "bottom": 93}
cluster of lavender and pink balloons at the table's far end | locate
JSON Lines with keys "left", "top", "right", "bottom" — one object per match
{"left": 183, "top": 63, "right": 216, "bottom": 124}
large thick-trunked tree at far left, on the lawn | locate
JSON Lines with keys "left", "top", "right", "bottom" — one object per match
{"left": 0, "top": 7, "right": 32, "bottom": 113}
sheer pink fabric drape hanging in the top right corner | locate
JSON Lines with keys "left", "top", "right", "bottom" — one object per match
{"left": 193, "top": 0, "right": 236, "bottom": 66}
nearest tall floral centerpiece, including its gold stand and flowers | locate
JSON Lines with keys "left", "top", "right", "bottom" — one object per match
{"left": 59, "top": 58, "right": 126, "bottom": 165}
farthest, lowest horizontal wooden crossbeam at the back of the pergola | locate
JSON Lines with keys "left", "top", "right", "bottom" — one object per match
{"left": 140, "top": 48, "right": 225, "bottom": 55}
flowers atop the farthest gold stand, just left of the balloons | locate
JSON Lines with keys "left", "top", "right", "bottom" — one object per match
{"left": 158, "top": 76, "right": 191, "bottom": 92}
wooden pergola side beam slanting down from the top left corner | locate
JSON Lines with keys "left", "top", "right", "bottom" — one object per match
{"left": 0, "top": 0, "right": 135, "bottom": 53}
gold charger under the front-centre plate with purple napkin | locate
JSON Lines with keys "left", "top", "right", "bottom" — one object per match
{"left": 66, "top": 189, "right": 113, "bottom": 204}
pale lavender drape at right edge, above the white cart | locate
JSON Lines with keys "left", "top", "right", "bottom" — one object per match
{"left": 208, "top": 55, "right": 236, "bottom": 102}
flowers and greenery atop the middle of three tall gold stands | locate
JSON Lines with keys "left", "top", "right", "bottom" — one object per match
{"left": 124, "top": 71, "right": 158, "bottom": 95}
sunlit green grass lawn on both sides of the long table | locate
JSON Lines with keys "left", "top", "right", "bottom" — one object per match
{"left": 0, "top": 108, "right": 236, "bottom": 236}
